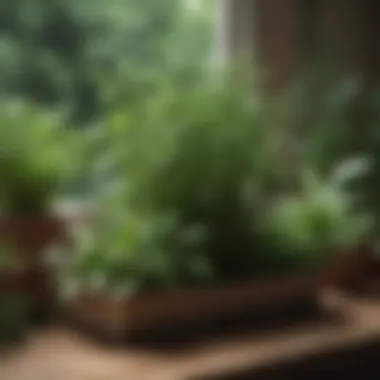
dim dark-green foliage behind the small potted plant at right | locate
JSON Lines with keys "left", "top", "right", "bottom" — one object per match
{"left": 285, "top": 57, "right": 380, "bottom": 267}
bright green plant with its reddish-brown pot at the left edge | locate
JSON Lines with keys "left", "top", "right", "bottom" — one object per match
{"left": 0, "top": 102, "right": 76, "bottom": 316}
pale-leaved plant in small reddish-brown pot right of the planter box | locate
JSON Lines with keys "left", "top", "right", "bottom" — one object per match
{"left": 269, "top": 159, "right": 373, "bottom": 286}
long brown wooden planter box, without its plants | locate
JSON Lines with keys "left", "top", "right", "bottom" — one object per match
{"left": 67, "top": 274, "right": 319, "bottom": 338}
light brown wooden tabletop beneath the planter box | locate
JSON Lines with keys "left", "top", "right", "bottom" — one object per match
{"left": 0, "top": 297, "right": 380, "bottom": 380}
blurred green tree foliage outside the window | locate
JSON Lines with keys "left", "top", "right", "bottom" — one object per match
{"left": 0, "top": 0, "right": 212, "bottom": 122}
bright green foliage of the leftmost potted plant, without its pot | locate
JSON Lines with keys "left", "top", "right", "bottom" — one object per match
{"left": 0, "top": 103, "right": 75, "bottom": 215}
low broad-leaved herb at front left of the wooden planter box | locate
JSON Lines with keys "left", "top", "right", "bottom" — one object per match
{"left": 62, "top": 213, "right": 212, "bottom": 294}
